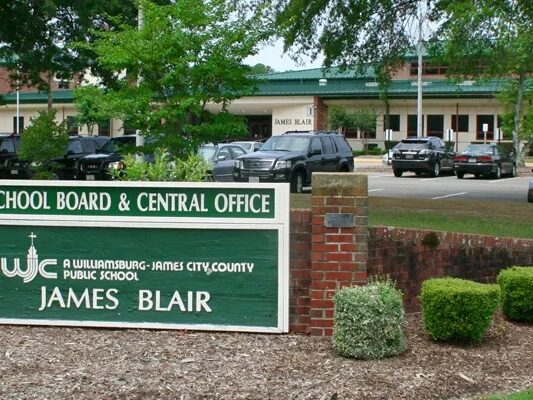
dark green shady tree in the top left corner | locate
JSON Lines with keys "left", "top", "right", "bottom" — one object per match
{"left": 0, "top": 0, "right": 141, "bottom": 112}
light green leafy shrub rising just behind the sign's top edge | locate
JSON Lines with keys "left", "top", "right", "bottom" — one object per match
{"left": 111, "top": 149, "right": 209, "bottom": 182}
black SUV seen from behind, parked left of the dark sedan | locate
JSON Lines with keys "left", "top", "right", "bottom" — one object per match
{"left": 392, "top": 136, "right": 455, "bottom": 177}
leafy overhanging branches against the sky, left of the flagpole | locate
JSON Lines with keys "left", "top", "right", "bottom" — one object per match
{"left": 276, "top": 0, "right": 419, "bottom": 81}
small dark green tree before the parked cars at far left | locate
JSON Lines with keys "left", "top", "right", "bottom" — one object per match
{"left": 18, "top": 111, "right": 68, "bottom": 167}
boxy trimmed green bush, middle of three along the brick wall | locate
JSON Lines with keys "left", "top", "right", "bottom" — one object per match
{"left": 420, "top": 278, "right": 500, "bottom": 342}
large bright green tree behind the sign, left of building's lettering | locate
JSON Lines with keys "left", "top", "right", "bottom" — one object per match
{"left": 76, "top": 0, "right": 268, "bottom": 154}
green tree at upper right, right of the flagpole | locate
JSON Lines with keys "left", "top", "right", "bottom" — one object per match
{"left": 431, "top": 0, "right": 533, "bottom": 165}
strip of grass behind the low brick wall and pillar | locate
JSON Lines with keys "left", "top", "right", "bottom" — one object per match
{"left": 291, "top": 194, "right": 533, "bottom": 239}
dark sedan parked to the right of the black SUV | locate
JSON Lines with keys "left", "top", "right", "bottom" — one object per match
{"left": 453, "top": 143, "right": 516, "bottom": 179}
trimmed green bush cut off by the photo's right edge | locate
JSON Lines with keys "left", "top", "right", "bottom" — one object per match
{"left": 497, "top": 266, "right": 533, "bottom": 322}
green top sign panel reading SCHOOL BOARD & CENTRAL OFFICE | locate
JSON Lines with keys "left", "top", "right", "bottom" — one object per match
{"left": 0, "top": 182, "right": 275, "bottom": 218}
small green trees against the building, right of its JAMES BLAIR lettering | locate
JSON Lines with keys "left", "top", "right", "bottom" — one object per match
{"left": 327, "top": 106, "right": 376, "bottom": 137}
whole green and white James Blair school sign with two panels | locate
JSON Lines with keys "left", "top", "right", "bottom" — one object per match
{"left": 0, "top": 181, "right": 289, "bottom": 332}
